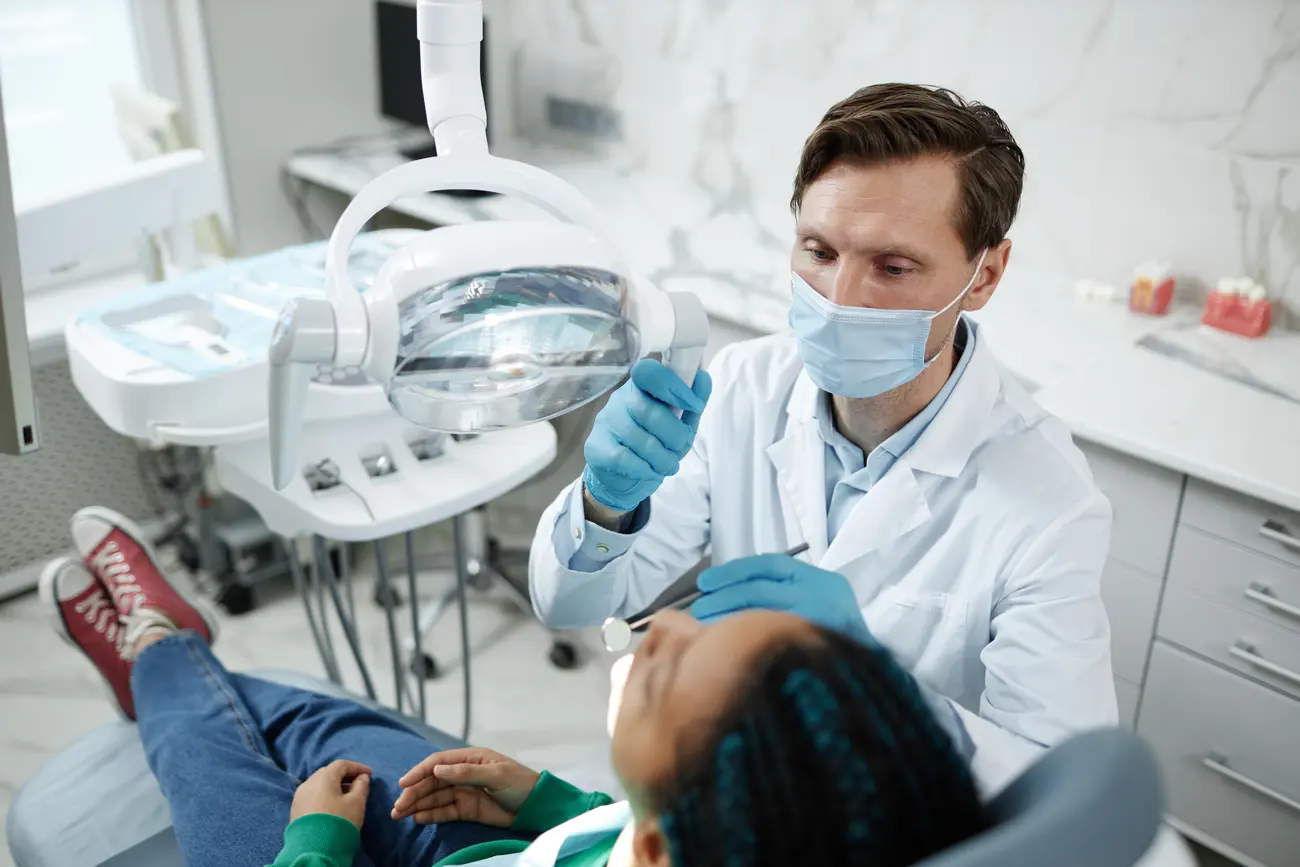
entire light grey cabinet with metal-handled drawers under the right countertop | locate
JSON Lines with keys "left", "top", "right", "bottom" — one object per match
{"left": 1080, "top": 443, "right": 1300, "bottom": 867}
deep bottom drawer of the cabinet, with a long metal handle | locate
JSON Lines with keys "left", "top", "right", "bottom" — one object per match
{"left": 1138, "top": 641, "right": 1300, "bottom": 867}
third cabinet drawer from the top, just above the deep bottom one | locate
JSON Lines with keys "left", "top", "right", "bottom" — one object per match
{"left": 1158, "top": 586, "right": 1300, "bottom": 697}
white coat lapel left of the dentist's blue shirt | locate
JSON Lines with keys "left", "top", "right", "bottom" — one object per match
{"left": 767, "top": 373, "right": 827, "bottom": 563}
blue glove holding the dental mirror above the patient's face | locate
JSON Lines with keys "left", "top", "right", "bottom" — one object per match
{"left": 690, "top": 554, "right": 875, "bottom": 643}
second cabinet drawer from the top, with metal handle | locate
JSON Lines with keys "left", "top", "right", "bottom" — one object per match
{"left": 1169, "top": 524, "right": 1300, "bottom": 632}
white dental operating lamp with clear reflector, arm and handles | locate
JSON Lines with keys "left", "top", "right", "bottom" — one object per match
{"left": 268, "top": 0, "right": 709, "bottom": 490}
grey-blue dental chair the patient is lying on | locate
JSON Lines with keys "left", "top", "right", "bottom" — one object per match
{"left": 8, "top": 672, "right": 1164, "bottom": 867}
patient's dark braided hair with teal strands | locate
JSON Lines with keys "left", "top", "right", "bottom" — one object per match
{"left": 649, "top": 630, "right": 982, "bottom": 867}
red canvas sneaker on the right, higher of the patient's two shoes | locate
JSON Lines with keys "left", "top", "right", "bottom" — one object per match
{"left": 73, "top": 506, "right": 217, "bottom": 645}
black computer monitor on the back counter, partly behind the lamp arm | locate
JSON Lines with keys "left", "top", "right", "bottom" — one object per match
{"left": 374, "top": 0, "right": 490, "bottom": 160}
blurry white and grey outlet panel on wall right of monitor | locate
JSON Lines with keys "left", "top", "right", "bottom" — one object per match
{"left": 515, "top": 45, "right": 623, "bottom": 144}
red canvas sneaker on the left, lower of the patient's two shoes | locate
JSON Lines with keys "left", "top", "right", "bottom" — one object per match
{"left": 40, "top": 556, "right": 135, "bottom": 719}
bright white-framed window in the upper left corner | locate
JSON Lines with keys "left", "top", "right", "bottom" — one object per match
{"left": 0, "top": 0, "right": 225, "bottom": 292}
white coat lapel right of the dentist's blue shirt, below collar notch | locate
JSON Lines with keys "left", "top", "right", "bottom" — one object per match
{"left": 814, "top": 459, "right": 930, "bottom": 572}
